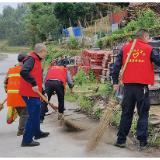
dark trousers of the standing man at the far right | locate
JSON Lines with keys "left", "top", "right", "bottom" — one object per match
{"left": 117, "top": 84, "right": 150, "bottom": 143}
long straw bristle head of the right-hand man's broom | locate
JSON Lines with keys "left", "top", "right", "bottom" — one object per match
{"left": 86, "top": 99, "right": 115, "bottom": 152}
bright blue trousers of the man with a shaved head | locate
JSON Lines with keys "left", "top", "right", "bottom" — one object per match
{"left": 22, "top": 96, "right": 42, "bottom": 143}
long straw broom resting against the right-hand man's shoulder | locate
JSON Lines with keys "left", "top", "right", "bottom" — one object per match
{"left": 86, "top": 39, "right": 136, "bottom": 152}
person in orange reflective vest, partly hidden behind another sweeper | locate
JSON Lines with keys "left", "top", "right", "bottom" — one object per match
{"left": 4, "top": 53, "right": 28, "bottom": 136}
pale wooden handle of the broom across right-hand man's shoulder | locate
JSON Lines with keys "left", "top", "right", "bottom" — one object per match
{"left": 112, "top": 39, "right": 136, "bottom": 98}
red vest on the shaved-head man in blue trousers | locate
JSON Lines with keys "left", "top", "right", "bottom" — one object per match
{"left": 19, "top": 53, "right": 42, "bottom": 97}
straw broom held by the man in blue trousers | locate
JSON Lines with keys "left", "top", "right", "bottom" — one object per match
{"left": 37, "top": 91, "right": 86, "bottom": 130}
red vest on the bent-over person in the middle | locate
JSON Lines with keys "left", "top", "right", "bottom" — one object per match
{"left": 45, "top": 66, "right": 67, "bottom": 91}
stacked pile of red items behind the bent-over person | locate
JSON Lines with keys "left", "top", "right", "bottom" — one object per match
{"left": 50, "top": 48, "right": 114, "bottom": 83}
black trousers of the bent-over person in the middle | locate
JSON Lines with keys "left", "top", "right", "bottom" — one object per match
{"left": 40, "top": 80, "right": 64, "bottom": 120}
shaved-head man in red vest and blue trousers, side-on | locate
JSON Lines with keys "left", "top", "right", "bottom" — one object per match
{"left": 19, "top": 43, "right": 49, "bottom": 147}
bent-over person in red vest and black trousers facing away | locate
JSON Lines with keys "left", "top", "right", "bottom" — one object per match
{"left": 40, "top": 59, "right": 75, "bottom": 123}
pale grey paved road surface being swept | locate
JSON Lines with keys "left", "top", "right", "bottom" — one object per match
{"left": 0, "top": 54, "right": 156, "bottom": 158}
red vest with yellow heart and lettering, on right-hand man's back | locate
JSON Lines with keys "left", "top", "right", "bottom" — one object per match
{"left": 123, "top": 39, "right": 154, "bottom": 85}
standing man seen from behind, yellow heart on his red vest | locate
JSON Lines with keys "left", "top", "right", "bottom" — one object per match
{"left": 112, "top": 29, "right": 160, "bottom": 149}
